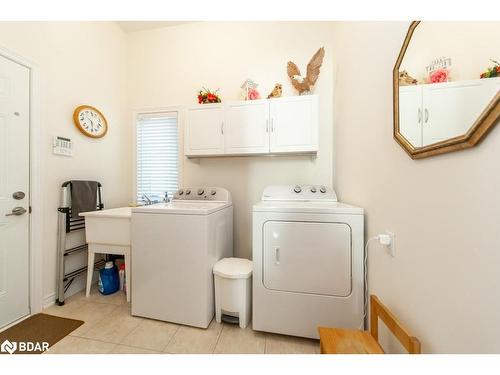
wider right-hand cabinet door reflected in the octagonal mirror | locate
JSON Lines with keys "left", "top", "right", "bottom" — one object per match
{"left": 423, "top": 79, "right": 492, "bottom": 146}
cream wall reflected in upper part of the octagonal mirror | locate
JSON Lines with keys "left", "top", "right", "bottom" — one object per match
{"left": 400, "top": 21, "right": 500, "bottom": 82}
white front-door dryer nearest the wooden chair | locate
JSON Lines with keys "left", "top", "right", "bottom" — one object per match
{"left": 253, "top": 185, "right": 364, "bottom": 338}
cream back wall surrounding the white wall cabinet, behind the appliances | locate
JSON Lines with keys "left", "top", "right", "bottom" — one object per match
{"left": 128, "top": 22, "right": 334, "bottom": 257}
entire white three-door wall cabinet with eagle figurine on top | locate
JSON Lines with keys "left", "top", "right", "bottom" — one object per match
{"left": 184, "top": 95, "right": 319, "bottom": 157}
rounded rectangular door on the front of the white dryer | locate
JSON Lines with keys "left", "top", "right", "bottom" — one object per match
{"left": 262, "top": 221, "right": 351, "bottom": 297}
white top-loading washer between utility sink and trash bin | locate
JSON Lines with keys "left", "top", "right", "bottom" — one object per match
{"left": 131, "top": 187, "right": 233, "bottom": 328}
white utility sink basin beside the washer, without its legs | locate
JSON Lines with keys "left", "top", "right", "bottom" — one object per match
{"left": 80, "top": 207, "right": 131, "bottom": 246}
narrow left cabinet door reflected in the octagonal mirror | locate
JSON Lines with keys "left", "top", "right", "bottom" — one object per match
{"left": 399, "top": 86, "right": 423, "bottom": 147}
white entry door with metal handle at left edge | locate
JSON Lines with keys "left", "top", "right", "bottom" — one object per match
{"left": 0, "top": 56, "right": 30, "bottom": 327}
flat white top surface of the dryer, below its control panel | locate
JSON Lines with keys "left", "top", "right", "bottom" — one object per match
{"left": 253, "top": 201, "right": 363, "bottom": 215}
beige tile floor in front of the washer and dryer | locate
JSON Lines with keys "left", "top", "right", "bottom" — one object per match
{"left": 44, "top": 289, "right": 319, "bottom": 354}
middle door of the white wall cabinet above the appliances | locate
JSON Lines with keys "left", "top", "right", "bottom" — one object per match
{"left": 224, "top": 100, "right": 269, "bottom": 154}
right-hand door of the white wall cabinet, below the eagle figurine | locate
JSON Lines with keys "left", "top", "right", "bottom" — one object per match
{"left": 270, "top": 95, "right": 319, "bottom": 153}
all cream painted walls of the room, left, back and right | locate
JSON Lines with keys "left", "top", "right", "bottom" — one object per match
{"left": 0, "top": 22, "right": 500, "bottom": 353}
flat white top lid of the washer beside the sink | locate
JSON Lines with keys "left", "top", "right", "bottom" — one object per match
{"left": 132, "top": 201, "right": 232, "bottom": 215}
